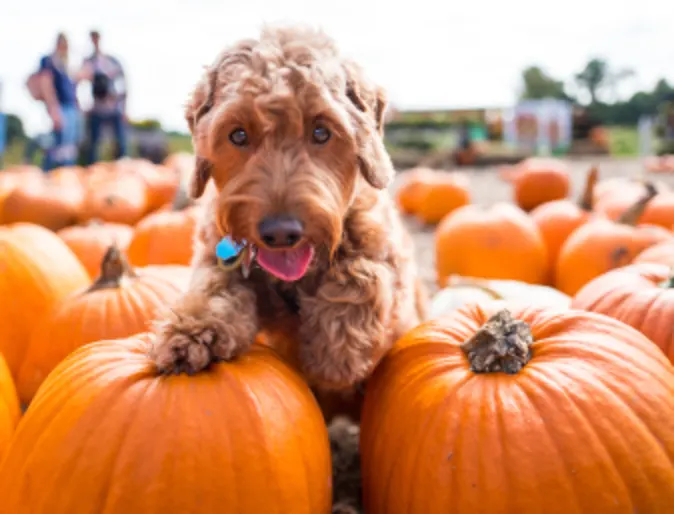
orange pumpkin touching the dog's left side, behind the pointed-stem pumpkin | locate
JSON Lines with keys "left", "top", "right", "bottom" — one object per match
{"left": 127, "top": 190, "right": 201, "bottom": 266}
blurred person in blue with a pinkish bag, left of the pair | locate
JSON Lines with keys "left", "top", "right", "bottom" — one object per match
{"left": 28, "top": 33, "right": 80, "bottom": 171}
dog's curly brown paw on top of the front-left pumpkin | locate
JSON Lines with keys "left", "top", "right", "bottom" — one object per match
{"left": 152, "top": 312, "right": 251, "bottom": 374}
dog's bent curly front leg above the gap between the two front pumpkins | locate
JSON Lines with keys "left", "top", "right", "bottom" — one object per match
{"left": 300, "top": 257, "right": 393, "bottom": 389}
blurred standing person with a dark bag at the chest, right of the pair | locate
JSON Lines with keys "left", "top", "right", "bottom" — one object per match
{"left": 78, "top": 30, "right": 128, "bottom": 164}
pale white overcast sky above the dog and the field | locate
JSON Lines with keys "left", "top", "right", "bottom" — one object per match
{"left": 0, "top": 0, "right": 674, "bottom": 132}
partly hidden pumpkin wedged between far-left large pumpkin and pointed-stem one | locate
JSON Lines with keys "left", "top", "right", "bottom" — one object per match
{"left": 57, "top": 220, "right": 133, "bottom": 279}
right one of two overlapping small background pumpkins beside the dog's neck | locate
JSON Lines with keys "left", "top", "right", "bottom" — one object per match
{"left": 416, "top": 171, "right": 470, "bottom": 225}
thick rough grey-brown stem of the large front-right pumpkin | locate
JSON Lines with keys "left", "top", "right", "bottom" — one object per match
{"left": 461, "top": 309, "right": 534, "bottom": 375}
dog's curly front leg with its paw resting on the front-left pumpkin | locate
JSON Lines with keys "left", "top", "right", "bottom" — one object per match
{"left": 152, "top": 265, "right": 258, "bottom": 373}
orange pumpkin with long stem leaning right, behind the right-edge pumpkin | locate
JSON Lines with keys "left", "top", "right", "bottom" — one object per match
{"left": 555, "top": 183, "right": 672, "bottom": 296}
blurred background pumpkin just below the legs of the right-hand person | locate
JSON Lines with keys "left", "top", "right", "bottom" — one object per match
{"left": 80, "top": 172, "right": 148, "bottom": 225}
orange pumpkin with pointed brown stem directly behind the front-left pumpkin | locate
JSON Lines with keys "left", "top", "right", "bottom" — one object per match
{"left": 17, "top": 246, "right": 187, "bottom": 405}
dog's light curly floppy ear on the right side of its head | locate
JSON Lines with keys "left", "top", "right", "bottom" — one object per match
{"left": 345, "top": 64, "right": 395, "bottom": 189}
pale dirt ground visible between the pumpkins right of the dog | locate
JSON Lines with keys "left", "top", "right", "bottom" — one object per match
{"left": 391, "top": 157, "right": 674, "bottom": 292}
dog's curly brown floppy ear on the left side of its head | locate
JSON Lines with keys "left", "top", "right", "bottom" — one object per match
{"left": 185, "top": 69, "right": 217, "bottom": 198}
